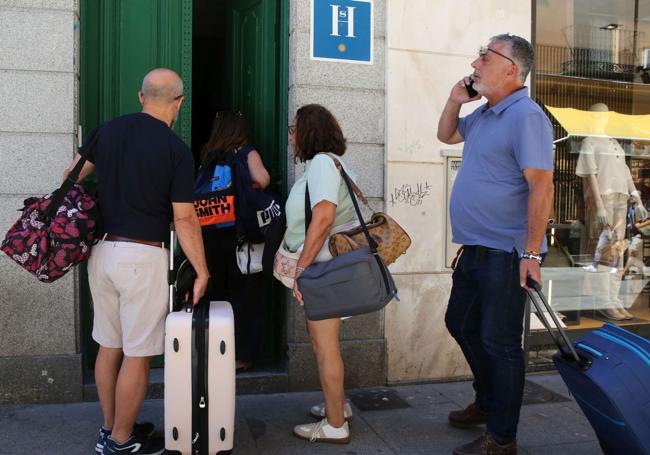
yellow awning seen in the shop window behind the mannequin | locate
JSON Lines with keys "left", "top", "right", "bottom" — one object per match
{"left": 545, "top": 106, "right": 650, "bottom": 142}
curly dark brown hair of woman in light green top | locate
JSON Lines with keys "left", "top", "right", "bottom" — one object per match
{"left": 294, "top": 104, "right": 346, "bottom": 162}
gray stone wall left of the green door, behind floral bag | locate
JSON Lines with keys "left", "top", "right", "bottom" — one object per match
{"left": 0, "top": 0, "right": 82, "bottom": 403}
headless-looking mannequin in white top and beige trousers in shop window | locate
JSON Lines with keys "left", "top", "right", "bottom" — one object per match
{"left": 576, "top": 103, "right": 648, "bottom": 320}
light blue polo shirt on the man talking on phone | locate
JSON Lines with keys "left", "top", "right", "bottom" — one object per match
{"left": 449, "top": 87, "right": 553, "bottom": 253}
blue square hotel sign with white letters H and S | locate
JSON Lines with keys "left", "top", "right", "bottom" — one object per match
{"left": 311, "top": 0, "right": 373, "bottom": 64}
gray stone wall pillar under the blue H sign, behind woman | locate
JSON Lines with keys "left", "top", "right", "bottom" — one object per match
{"left": 287, "top": 0, "right": 386, "bottom": 390}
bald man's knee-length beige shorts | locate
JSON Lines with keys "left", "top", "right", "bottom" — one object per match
{"left": 88, "top": 240, "right": 169, "bottom": 357}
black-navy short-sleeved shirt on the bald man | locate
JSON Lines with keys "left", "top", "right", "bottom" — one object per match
{"left": 83, "top": 113, "right": 194, "bottom": 242}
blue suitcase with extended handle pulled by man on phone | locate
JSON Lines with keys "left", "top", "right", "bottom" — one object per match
{"left": 529, "top": 281, "right": 650, "bottom": 455}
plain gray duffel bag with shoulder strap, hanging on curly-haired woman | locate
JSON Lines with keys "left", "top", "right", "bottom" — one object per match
{"left": 298, "top": 167, "right": 397, "bottom": 321}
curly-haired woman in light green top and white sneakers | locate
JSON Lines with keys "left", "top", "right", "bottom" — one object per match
{"left": 284, "top": 104, "right": 356, "bottom": 443}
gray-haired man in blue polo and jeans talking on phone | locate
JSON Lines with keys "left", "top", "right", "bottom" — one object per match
{"left": 438, "top": 34, "right": 553, "bottom": 455}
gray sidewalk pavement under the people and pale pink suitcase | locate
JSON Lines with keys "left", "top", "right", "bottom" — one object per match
{"left": 0, "top": 374, "right": 601, "bottom": 455}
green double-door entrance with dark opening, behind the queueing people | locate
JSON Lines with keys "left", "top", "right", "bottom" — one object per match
{"left": 79, "top": 0, "right": 289, "bottom": 369}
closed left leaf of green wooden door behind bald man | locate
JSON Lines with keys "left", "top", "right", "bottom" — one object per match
{"left": 79, "top": 0, "right": 192, "bottom": 368}
